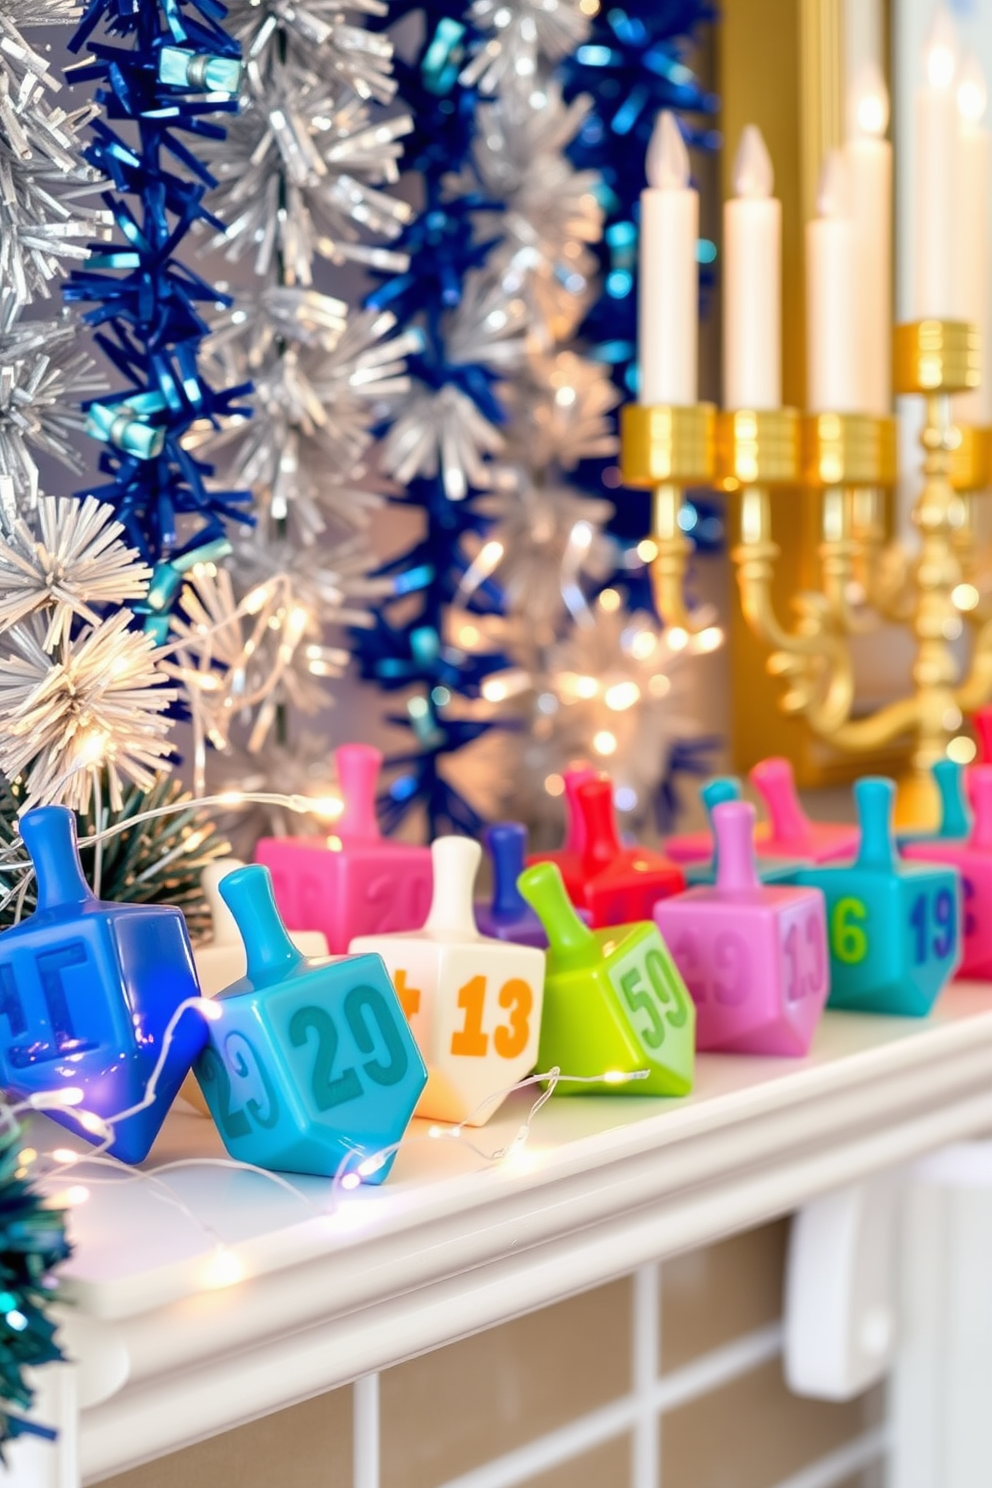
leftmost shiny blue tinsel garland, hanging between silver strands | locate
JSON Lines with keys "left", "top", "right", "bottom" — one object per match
{"left": 64, "top": 0, "right": 250, "bottom": 561}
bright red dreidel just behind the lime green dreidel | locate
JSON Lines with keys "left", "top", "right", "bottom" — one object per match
{"left": 579, "top": 780, "right": 686, "bottom": 927}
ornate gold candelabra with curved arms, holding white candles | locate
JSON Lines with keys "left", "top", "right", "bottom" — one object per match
{"left": 622, "top": 320, "right": 992, "bottom": 797}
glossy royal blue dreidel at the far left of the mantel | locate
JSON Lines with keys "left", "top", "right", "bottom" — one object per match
{"left": 0, "top": 806, "right": 207, "bottom": 1162}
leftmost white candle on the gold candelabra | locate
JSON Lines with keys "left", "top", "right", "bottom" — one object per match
{"left": 638, "top": 112, "right": 699, "bottom": 408}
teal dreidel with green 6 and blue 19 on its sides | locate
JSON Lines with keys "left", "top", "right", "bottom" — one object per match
{"left": 796, "top": 778, "right": 961, "bottom": 1018}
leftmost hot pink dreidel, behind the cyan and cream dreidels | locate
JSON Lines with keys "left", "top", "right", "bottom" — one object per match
{"left": 254, "top": 744, "right": 431, "bottom": 954}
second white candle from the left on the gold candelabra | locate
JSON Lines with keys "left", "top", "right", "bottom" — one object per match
{"left": 723, "top": 124, "right": 782, "bottom": 409}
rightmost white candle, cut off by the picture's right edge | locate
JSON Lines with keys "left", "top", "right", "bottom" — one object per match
{"left": 955, "top": 57, "right": 992, "bottom": 424}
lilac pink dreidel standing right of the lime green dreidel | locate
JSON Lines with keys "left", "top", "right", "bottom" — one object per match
{"left": 654, "top": 801, "right": 830, "bottom": 1055}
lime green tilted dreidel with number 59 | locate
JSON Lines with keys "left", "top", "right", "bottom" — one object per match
{"left": 521, "top": 863, "right": 696, "bottom": 1095}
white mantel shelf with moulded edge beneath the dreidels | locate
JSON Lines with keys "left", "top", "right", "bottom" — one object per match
{"left": 49, "top": 984, "right": 992, "bottom": 1481}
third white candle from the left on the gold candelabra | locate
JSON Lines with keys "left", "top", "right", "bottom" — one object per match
{"left": 806, "top": 150, "right": 861, "bottom": 414}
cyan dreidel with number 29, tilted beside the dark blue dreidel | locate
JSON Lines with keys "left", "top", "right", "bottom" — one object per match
{"left": 196, "top": 865, "right": 427, "bottom": 1183}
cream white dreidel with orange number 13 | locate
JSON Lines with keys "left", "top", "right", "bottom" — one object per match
{"left": 350, "top": 836, "right": 544, "bottom": 1126}
